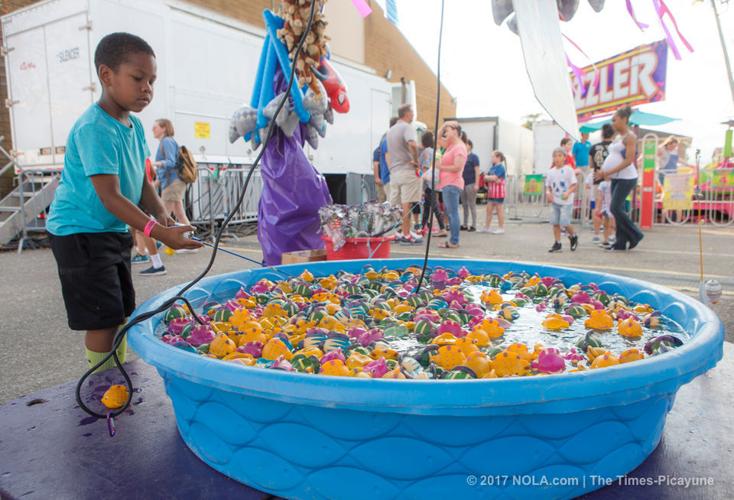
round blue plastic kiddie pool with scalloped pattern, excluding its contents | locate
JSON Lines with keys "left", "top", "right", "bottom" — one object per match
{"left": 129, "top": 259, "right": 724, "bottom": 500}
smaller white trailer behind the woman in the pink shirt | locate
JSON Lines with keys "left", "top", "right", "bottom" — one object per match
{"left": 449, "top": 116, "right": 533, "bottom": 177}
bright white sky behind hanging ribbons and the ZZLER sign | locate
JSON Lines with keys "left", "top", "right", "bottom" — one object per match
{"left": 397, "top": 0, "right": 734, "bottom": 162}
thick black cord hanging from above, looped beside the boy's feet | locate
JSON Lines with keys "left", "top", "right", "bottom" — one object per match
{"left": 76, "top": 0, "right": 320, "bottom": 418}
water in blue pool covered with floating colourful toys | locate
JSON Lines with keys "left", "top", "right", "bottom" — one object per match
{"left": 158, "top": 267, "right": 688, "bottom": 379}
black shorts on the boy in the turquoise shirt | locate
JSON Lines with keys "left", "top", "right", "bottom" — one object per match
{"left": 51, "top": 233, "right": 135, "bottom": 330}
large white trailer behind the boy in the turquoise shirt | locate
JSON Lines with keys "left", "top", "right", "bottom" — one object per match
{"left": 2, "top": 0, "right": 393, "bottom": 174}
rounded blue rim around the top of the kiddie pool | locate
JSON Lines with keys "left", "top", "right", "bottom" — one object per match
{"left": 129, "top": 259, "right": 724, "bottom": 415}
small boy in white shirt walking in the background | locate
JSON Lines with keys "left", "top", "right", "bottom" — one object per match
{"left": 545, "top": 148, "right": 579, "bottom": 253}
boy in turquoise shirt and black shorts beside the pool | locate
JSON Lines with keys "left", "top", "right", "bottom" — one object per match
{"left": 47, "top": 33, "right": 201, "bottom": 370}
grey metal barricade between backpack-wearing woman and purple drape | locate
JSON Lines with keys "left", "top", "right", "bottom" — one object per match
{"left": 186, "top": 163, "right": 262, "bottom": 230}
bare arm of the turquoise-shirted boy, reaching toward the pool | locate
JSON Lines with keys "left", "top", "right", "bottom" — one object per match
{"left": 90, "top": 174, "right": 201, "bottom": 250}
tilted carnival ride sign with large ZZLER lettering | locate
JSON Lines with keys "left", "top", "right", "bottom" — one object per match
{"left": 571, "top": 40, "right": 668, "bottom": 121}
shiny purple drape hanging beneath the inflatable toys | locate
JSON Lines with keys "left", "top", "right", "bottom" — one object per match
{"left": 257, "top": 70, "right": 331, "bottom": 266}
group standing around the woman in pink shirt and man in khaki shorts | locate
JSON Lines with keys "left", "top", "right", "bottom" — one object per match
{"left": 372, "top": 105, "right": 507, "bottom": 248}
